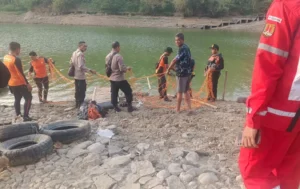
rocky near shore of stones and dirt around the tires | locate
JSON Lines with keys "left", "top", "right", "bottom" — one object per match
{"left": 0, "top": 102, "right": 244, "bottom": 189}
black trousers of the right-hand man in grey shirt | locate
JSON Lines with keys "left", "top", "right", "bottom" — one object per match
{"left": 110, "top": 80, "right": 133, "bottom": 107}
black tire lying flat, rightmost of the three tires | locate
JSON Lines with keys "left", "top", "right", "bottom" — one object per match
{"left": 40, "top": 120, "right": 91, "bottom": 144}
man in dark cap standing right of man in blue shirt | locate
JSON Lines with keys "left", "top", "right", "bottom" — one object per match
{"left": 205, "top": 44, "right": 224, "bottom": 102}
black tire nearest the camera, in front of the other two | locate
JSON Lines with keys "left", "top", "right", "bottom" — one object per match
{"left": 0, "top": 134, "right": 53, "bottom": 166}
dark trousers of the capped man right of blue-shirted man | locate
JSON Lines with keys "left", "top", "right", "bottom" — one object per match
{"left": 208, "top": 71, "right": 221, "bottom": 100}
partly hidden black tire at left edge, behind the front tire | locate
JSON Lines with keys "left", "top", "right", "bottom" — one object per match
{"left": 0, "top": 122, "right": 39, "bottom": 142}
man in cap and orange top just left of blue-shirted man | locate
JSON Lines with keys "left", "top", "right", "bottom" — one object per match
{"left": 155, "top": 47, "right": 173, "bottom": 102}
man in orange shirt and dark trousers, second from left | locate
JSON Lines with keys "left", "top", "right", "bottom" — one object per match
{"left": 28, "top": 51, "right": 51, "bottom": 103}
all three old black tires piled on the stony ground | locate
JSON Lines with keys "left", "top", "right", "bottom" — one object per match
{"left": 0, "top": 120, "right": 91, "bottom": 166}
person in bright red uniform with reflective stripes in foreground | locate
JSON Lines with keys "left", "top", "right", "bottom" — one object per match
{"left": 239, "top": 0, "right": 300, "bottom": 189}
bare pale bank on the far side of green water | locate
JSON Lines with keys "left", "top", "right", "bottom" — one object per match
{"left": 0, "top": 12, "right": 264, "bottom": 32}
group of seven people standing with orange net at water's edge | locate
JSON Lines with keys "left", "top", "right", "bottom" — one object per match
{"left": 0, "top": 33, "right": 224, "bottom": 121}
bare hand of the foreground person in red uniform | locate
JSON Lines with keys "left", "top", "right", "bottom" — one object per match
{"left": 242, "top": 126, "right": 258, "bottom": 148}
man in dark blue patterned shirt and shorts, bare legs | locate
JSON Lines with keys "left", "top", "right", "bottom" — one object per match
{"left": 167, "top": 33, "right": 192, "bottom": 112}
